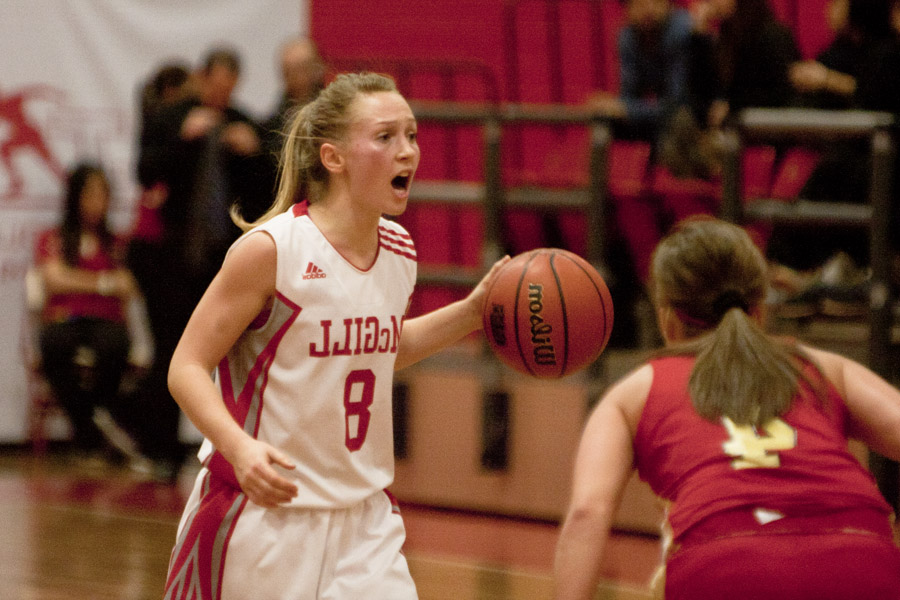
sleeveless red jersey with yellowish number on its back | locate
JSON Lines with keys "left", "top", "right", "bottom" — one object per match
{"left": 634, "top": 356, "right": 891, "bottom": 541}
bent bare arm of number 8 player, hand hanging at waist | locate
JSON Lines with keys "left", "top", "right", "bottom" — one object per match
{"left": 169, "top": 233, "right": 297, "bottom": 506}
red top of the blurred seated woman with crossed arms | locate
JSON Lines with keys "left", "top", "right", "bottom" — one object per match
{"left": 36, "top": 229, "right": 125, "bottom": 322}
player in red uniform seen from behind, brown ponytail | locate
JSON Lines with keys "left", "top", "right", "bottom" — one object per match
{"left": 555, "top": 219, "right": 900, "bottom": 600}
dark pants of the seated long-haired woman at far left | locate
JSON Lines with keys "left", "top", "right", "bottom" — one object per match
{"left": 40, "top": 318, "right": 130, "bottom": 450}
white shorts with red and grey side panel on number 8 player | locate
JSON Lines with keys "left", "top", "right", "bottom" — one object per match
{"left": 165, "top": 468, "right": 418, "bottom": 600}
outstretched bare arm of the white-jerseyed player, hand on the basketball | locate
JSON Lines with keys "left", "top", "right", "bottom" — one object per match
{"left": 394, "top": 256, "right": 510, "bottom": 370}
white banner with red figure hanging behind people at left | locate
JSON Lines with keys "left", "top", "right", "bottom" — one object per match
{"left": 0, "top": 0, "right": 308, "bottom": 443}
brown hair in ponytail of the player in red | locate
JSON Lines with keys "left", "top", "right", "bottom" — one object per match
{"left": 651, "top": 219, "right": 808, "bottom": 425}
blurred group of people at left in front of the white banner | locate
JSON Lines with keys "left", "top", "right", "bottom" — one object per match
{"left": 35, "top": 38, "right": 325, "bottom": 481}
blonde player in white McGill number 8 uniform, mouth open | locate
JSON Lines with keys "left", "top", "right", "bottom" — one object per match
{"left": 165, "top": 74, "right": 508, "bottom": 600}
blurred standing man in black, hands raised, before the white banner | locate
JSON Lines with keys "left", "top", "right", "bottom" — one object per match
{"left": 132, "top": 48, "right": 269, "bottom": 478}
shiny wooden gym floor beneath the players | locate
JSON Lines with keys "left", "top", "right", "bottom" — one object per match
{"left": 0, "top": 449, "right": 658, "bottom": 600}
